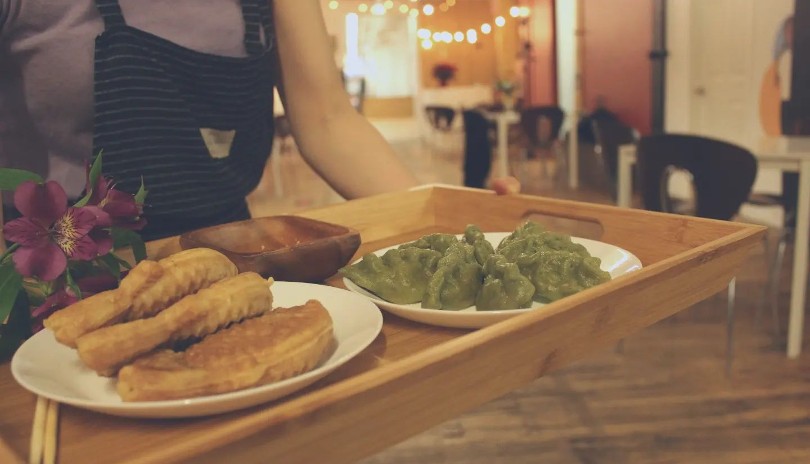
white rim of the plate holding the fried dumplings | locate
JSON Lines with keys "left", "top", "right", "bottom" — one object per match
{"left": 10, "top": 281, "right": 383, "bottom": 418}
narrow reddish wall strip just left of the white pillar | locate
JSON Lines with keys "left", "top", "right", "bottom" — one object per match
{"left": 526, "top": 0, "right": 557, "bottom": 105}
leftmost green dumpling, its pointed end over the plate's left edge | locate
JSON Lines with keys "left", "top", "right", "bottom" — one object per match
{"left": 339, "top": 248, "right": 442, "bottom": 304}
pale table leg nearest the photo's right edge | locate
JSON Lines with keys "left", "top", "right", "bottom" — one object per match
{"left": 787, "top": 159, "right": 810, "bottom": 358}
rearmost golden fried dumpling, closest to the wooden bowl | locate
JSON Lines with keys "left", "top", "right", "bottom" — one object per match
{"left": 44, "top": 248, "right": 238, "bottom": 347}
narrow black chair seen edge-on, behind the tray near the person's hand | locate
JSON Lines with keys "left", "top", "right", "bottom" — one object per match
{"left": 462, "top": 110, "right": 492, "bottom": 188}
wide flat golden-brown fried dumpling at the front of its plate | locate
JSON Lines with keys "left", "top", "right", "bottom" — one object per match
{"left": 117, "top": 300, "right": 333, "bottom": 401}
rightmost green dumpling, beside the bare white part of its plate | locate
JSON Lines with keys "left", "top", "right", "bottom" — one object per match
{"left": 517, "top": 249, "right": 610, "bottom": 303}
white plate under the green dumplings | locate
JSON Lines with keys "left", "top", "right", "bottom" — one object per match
{"left": 343, "top": 232, "right": 641, "bottom": 329}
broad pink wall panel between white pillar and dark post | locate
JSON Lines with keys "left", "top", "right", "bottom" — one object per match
{"left": 580, "top": 0, "right": 653, "bottom": 134}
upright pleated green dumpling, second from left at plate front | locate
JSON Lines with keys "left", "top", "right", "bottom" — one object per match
{"left": 422, "top": 242, "right": 483, "bottom": 310}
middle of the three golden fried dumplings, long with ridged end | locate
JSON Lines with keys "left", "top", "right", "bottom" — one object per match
{"left": 76, "top": 272, "right": 273, "bottom": 375}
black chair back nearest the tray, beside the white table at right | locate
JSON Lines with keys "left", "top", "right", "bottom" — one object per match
{"left": 638, "top": 134, "right": 757, "bottom": 220}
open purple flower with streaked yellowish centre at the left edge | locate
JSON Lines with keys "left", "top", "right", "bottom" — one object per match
{"left": 3, "top": 181, "right": 109, "bottom": 281}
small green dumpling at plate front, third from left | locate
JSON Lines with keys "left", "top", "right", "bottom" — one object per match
{"left": 475, "top": 255, "right": 534, "bottom": 311}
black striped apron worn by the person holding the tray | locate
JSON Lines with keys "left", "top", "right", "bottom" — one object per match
{"left": 93, "top": 0, "right": 274, "bottom": 240}
